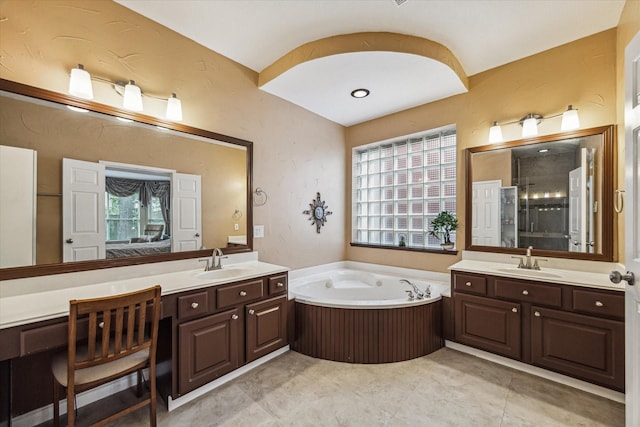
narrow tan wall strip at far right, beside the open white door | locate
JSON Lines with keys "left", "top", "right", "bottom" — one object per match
{"left": 616, "top": 0, "right": 640, "bottom": 263}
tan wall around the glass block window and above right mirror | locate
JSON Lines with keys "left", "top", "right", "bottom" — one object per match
{"left": 346, "top": 29, "right": 622, "bottom": 271}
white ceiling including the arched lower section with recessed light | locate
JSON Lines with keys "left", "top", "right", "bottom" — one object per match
{"left": 116, "top": 0, "right": 625, "bottom": 126}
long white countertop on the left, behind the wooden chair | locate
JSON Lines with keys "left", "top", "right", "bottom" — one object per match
{"left": 0, "top": 260, "right": 289, "bottom": 329}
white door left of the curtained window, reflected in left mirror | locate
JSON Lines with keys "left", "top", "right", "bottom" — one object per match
{"left": 62, "top": 159, "right": 106, "bottom": 262}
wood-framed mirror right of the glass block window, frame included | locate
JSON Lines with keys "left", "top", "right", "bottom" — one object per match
{"left": 465, "top": 126, "right": 614, "bottom": 261}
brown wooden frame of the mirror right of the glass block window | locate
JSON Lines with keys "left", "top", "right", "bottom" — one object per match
{"left": 464, "top": 125, "right": 616, "bottom": 262}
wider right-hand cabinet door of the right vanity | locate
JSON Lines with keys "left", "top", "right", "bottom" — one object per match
{"left": 531, "top": 307, "right": 624, "bottom": 391}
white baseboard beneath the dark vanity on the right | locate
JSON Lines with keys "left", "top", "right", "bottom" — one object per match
{"left": 445, "top": 341, "right": 625, "bottom": 403}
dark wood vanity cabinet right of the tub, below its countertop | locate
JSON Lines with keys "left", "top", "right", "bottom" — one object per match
{"left": 451, "top": 271, "right": 624, "bottom": 391}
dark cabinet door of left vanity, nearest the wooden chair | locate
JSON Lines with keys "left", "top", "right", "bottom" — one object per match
{"left": 178, "top": 309, "right": 242, "bottom": 395}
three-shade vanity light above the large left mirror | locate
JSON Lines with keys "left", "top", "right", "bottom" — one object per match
{"left": 69, "top": 64, "right": 182, "bottom": 122}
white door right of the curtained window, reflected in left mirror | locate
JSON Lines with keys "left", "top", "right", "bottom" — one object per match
{"left": 171, "top": 173, "right": 202, "bottom": 252}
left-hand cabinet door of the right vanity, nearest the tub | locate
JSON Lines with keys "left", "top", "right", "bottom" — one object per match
{"left": 455, "top": 294, "right": 521, "bottom": 359}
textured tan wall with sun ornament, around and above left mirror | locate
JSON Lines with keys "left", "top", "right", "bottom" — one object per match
{"left": 0, "top": 0, "right": 346, "bottom": 268}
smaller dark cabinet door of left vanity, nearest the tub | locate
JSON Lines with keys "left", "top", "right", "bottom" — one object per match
{"left": 245, "top": 295, "right": 287, "bottom": 363}
